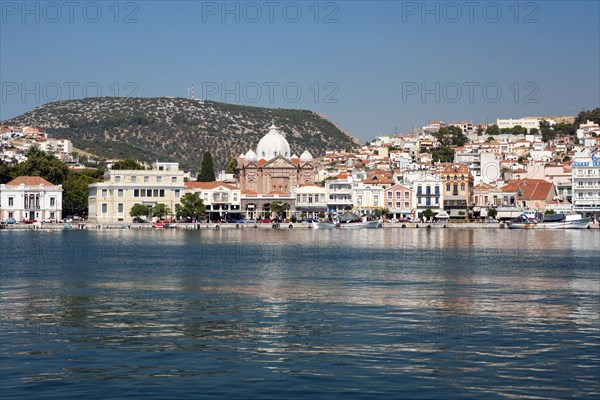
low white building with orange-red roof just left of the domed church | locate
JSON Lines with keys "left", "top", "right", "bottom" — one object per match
{"left": 188, "top": 181, "right": 242, "bottom": 221}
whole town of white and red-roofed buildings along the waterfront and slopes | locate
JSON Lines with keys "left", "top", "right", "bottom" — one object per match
{"left": 0, "top": 111, "right": 600, "bottom": 224}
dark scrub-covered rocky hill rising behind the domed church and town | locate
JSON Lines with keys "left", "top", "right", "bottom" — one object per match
{"left": 5, "top": 97, "right": 357, "bottom": 171}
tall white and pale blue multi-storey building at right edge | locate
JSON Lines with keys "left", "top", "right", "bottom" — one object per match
{"left": 571, "top": 150, "right": 600, "bottom": 219}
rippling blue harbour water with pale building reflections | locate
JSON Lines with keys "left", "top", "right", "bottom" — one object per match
{"left": 0, "top": 229, "right": 600, "bottom": 399}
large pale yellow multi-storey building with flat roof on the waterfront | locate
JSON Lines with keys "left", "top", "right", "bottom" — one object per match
{"left": 88, "top": 162, "right": 185, "bottom": 223}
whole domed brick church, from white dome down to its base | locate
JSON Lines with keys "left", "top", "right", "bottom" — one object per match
{"left": 236, "top": 125, "right": 316, "bottom": 217}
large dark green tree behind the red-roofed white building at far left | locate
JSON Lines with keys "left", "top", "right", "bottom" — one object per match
{"left": 12, "top": 146, "right": 69, "bottom": 185}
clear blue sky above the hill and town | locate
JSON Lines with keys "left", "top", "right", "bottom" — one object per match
{"left": 0, "top": 0, "right": 600, "bottom": 140}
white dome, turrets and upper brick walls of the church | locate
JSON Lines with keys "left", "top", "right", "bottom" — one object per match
{"left": 237, "top": 125, "right": 316, "bottom": 194}
